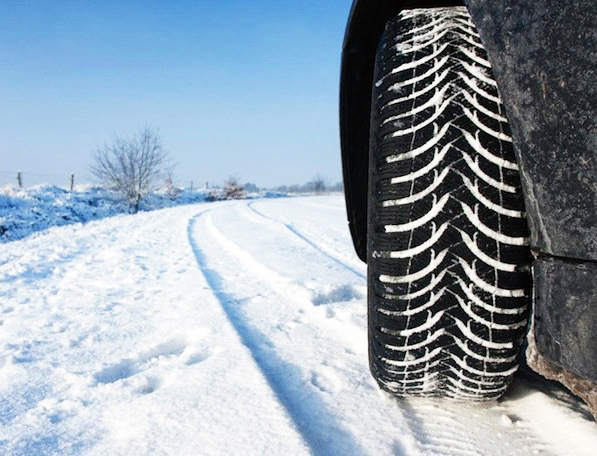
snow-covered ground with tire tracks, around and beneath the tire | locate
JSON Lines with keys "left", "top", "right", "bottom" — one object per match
{"left": 0, "top": 196, "right": 597, "bottom": 456}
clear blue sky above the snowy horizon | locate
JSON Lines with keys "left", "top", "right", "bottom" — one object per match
{"left": 0, "top": 0, "right": 351, "bottom": 187}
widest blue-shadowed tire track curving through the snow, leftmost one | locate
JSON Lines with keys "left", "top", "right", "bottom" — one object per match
{"left": 187, "top": 211, "right": 363, "bottom": 455}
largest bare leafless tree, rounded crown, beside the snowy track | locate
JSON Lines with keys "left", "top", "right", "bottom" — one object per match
{"left": 91, "top": 128, "right": 168, "bottom": 212}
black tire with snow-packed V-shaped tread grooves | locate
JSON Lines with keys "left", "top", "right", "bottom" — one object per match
{"left": 367, "top": 8, "right": 531, "bottom": 400}
